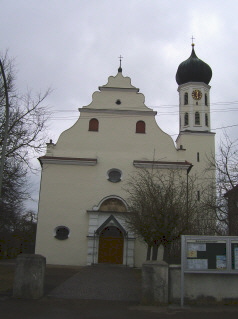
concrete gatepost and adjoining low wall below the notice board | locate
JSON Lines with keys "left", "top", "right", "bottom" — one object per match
{"left": 141, "top": 261, "right": 238, "bottom": 305}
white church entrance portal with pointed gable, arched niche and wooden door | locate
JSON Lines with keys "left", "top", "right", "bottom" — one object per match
{"left": 88, "top": 199, "right": 128, "bottom": 266}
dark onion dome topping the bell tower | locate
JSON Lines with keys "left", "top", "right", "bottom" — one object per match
{"left": 176, "top": 44, "right": 212, "bottom": 85}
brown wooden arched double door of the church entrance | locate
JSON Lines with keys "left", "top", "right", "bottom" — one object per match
{"left": 98, "top": 226, "right": 124, "bottom": 264}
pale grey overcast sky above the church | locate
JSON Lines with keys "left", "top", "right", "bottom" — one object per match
{"left": 0, "top": 0, "right": 238, "bottom": 214}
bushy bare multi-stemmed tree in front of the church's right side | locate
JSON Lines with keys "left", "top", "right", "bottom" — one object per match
{"left": 126, "top": 170, "right": 214, "bottom": 260}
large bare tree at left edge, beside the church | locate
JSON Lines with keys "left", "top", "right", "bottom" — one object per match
{"left": 0, "top": 52, "right": 50, "bottom": 222}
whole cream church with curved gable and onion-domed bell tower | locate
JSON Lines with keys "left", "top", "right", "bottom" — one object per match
{"left": 36, "top": 46, "right": 215, "bottom": 267}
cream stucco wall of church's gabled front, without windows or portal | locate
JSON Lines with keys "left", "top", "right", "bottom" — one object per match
{"left": 36, "top": 73, "right": 214, "bottom": 267}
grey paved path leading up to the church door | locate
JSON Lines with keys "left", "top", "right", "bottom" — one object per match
{"left": 48, "top": 265, "right": 141, "bottom": 301}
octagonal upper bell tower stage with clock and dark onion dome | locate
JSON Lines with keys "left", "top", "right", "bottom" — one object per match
{"left": 176, "top": 44, "right": 212, "bottom": 133}
